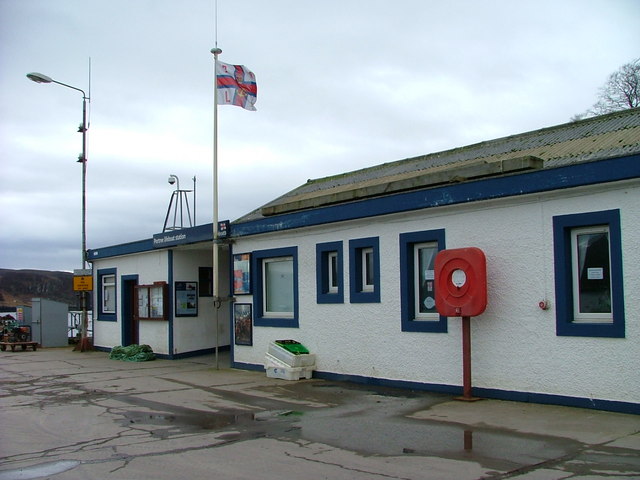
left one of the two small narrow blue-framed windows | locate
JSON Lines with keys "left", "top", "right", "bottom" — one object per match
{"left": 316, "top": 242, "right": 344, "bottom": 303}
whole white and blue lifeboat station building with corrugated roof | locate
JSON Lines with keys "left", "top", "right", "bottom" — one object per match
{"left": 89, "top": 109, "right": 640, "bottom": 413}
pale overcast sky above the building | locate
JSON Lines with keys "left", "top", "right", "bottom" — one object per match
{"left": 0, "top": 0, "right": 640, "bottom": 271}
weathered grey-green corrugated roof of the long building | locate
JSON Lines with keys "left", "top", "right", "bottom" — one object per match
{"left": 237, "top": 108, "right": 640, "bottom": 222}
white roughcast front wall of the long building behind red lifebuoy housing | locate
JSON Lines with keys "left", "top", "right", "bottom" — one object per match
{"left": 234, "top": 181, "right": 640, "bottom": 402}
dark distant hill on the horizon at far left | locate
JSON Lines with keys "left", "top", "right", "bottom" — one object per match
{"left": 0, "top": 268, "right": 80, "bottom": 310}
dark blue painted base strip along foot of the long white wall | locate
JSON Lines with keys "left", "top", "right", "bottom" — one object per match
{"left": 232, "top": 362, "right": 640, "bottom": 415}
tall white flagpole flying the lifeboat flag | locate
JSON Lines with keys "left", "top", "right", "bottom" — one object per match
{"left": 211, "top": 46, "right": 222, "bottom": 370}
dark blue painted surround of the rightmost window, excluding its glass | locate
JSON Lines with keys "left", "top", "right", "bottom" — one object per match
{"left": 553, "top": 209, "right": 625, "bottom": 338}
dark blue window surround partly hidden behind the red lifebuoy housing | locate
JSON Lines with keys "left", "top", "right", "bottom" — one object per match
{"left": 400, "top": 229, "right": 448, "bottom": 333}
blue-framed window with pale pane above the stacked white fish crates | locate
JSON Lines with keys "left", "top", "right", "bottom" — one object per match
{"left": 251, "top": 247, "right": 299, "bottom": 328}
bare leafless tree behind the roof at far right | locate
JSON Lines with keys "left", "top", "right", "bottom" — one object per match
{"left": 572, "top": 58, "right": 640, "bottom": 120}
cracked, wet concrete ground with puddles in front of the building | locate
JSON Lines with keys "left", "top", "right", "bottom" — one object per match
{"left": 0, "top": 348, "right": 640, "bottom": 480}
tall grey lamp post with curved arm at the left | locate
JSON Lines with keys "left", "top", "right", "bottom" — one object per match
{"left": 27, "top": 72, "right": 91, "bottom": 352}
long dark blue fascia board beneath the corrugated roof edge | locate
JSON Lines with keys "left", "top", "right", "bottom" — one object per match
{"left": 232, "top": 155, "right": 640, "bottom": 237}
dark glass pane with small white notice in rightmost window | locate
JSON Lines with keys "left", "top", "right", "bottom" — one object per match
{"left": 576, "top": 232, "right": 611, "bottom": 313}
